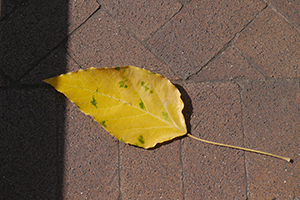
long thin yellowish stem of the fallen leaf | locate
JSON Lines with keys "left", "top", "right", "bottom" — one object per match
{"left": 187, "top": 133, "right": 293, "bottom": 162}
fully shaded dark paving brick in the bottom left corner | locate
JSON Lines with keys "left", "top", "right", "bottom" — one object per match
{"left": 0, "top": 88, "right": 63, "bottom": 199}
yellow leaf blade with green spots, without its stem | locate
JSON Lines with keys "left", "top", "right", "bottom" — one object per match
{"left": 44, "top": 66, "right": 187, "bottom": 148}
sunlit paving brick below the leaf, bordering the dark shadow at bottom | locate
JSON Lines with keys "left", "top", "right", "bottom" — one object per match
{"left": 62, "top": 98, "right": 119, "bottom": 199}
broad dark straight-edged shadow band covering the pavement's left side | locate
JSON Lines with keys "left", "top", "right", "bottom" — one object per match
{"left": 0, "top": 0, "right": 68, "bottom": 199}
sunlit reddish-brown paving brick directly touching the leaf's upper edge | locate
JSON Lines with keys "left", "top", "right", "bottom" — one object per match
{"left": 68, "top": 10, "right": 176, "bottom": 79}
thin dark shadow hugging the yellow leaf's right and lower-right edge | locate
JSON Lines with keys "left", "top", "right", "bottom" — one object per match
{"left": 148, "top": 84, "right": 193, "bottom": 150}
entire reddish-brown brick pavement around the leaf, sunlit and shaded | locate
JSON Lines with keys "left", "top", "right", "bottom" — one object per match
{"left": 0, "top": 0, "right": 300, "bottom": 200}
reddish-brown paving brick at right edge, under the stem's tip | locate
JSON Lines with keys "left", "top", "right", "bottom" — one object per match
{"left": 242, "top": 80, "right": 300, "bottom": 199}
